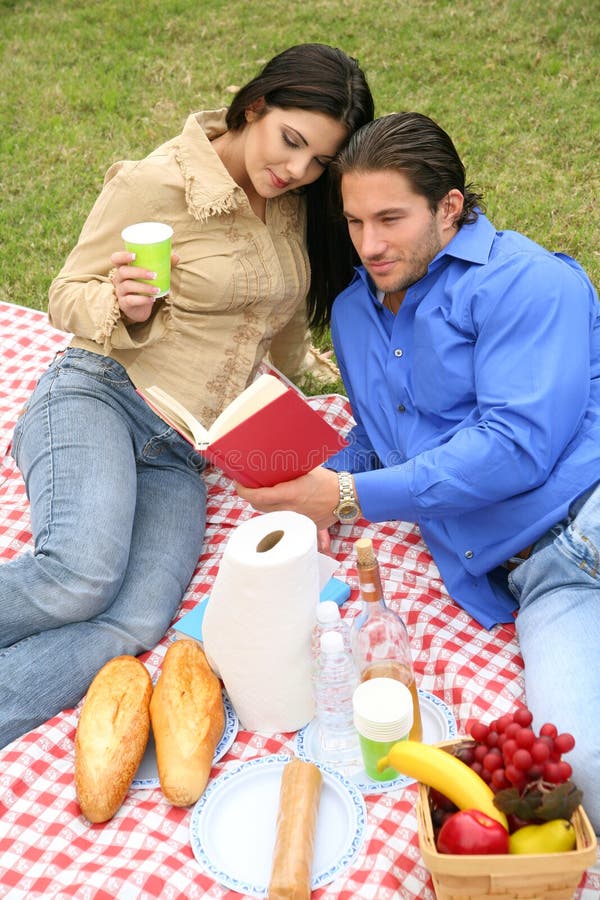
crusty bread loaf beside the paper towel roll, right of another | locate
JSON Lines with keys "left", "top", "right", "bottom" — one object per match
{"left": 150, "top": 640, "right": 225, "bottom": 806}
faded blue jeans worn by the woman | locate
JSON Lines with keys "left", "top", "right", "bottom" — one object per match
{"left": 0, "top": 349, "right": 206, "bottom": 746}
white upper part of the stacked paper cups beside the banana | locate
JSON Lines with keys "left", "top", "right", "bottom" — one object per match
{"left": 352, "top": 678, "right": 414, "bottom": 741}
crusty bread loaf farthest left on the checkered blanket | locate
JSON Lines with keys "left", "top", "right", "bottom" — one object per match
{"left": 75, "top": 656, "right": 152, "bottom": 822}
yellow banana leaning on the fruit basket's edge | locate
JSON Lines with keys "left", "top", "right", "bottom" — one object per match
{"left": 377, "top": 741, "right": 508, "bottom": 831}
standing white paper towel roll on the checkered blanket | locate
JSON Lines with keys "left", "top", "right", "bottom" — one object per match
{"left": 203, "top": 512, "right": 319, "bottom": 733}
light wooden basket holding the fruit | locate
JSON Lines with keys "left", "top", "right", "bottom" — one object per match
{"left": 417, "top": 741, "right": 597, "bottom": 900}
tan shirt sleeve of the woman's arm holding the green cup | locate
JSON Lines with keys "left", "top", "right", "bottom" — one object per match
{"left": 48, "top": 162, "right": 168, "bottom": 353}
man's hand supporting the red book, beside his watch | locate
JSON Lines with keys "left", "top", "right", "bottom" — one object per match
{"left": 235, "top": 466, "right": 339, "bottom": 530}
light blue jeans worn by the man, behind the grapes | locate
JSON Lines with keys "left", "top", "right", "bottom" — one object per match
{"left": 508, "top": 485, "right": 600, "bottom": 833}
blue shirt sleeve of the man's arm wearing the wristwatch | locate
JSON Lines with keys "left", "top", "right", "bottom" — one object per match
{"left": 355, "top": 255, "right": 595, "bottom": 521}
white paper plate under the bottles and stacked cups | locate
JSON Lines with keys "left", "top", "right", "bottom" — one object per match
{"left": 294, "top": 688, "right": 456, "bottom": 794}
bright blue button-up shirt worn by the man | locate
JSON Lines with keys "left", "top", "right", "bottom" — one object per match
{"left": 328, "top": 214, "right": 600, "bottom": 628}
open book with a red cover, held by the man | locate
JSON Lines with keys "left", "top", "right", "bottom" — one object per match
{"left": 138, "top": 374, "right": 347, "bottom": 487}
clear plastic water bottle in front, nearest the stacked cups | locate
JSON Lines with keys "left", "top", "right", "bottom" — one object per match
{"left": 314, "top": 631, "right": 362, "bottom": 775}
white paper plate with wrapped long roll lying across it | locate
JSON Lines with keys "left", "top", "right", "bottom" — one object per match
{"left": 190, "top": 754, "right": 367, "bottom": 897}
